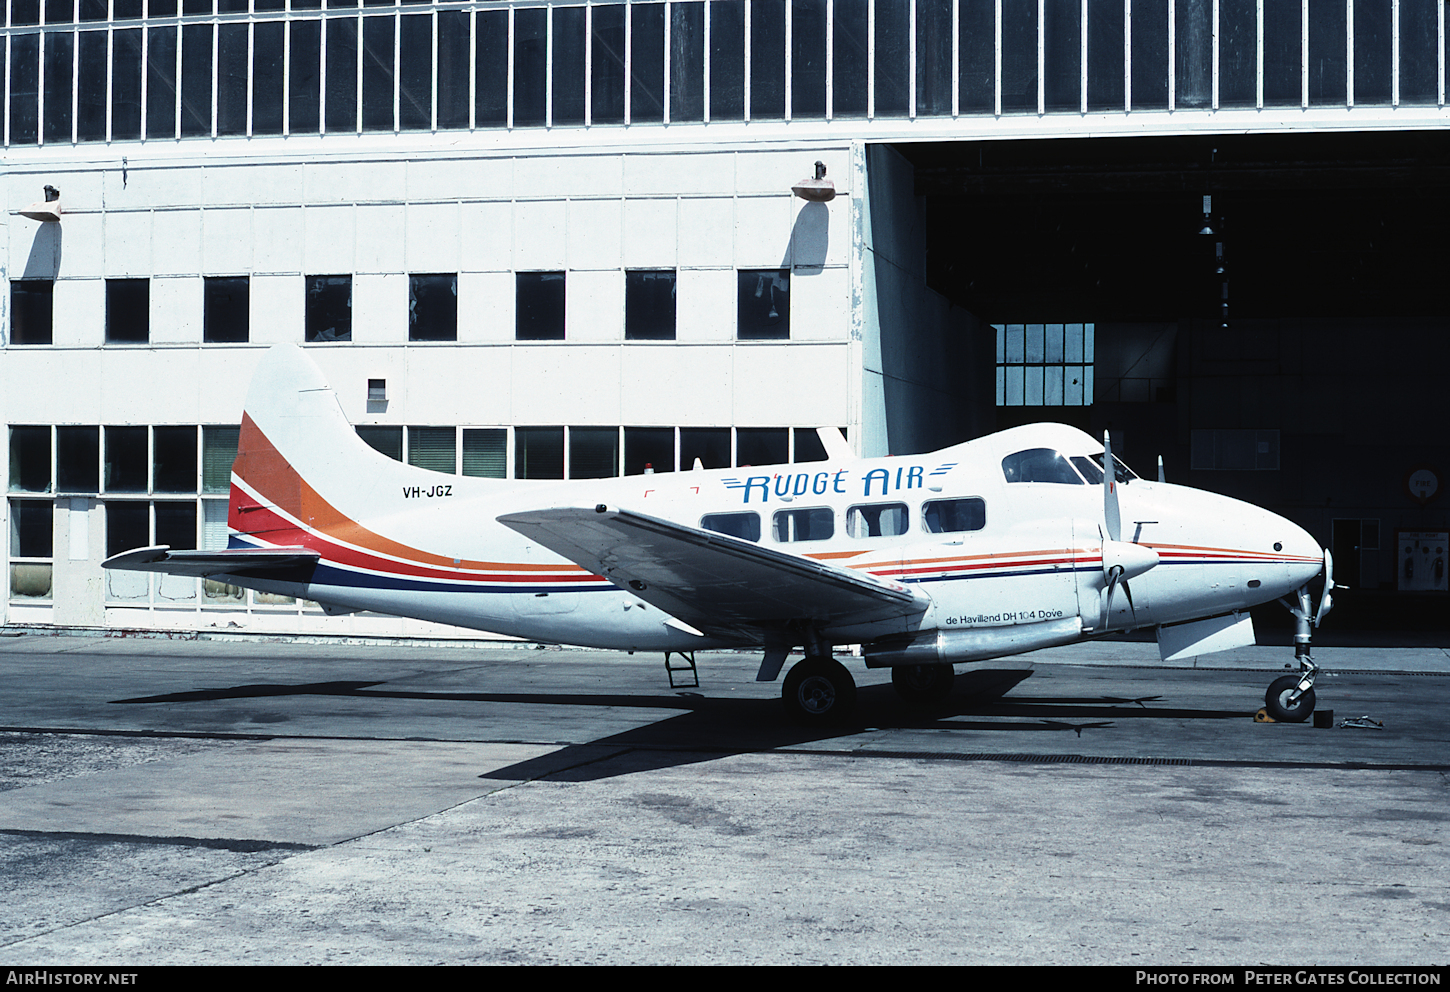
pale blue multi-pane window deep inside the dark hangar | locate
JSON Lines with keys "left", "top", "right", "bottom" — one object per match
{"left": 996, "top": 323, "right": 1093, "bottom": 406}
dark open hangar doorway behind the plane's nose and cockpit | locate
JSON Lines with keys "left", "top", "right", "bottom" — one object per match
{"left": 895, "top": 131, "right": 1450, "bottom": 627}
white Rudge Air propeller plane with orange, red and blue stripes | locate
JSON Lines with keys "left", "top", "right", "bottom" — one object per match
{"left": 104, "top": 345, "right": 1333, "bottom": 722}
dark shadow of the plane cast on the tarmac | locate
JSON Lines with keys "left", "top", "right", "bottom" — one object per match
{"left": 113, "top": 669, "right": 1244, "bottom": 782}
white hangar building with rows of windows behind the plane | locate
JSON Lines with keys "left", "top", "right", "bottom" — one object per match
{"left": 0, "top": 0, "right": 1450, "bottom": 635}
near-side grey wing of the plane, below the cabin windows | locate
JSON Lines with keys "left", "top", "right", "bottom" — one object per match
{"left": 499, "top": 505, "right": 928, "bottom": 635}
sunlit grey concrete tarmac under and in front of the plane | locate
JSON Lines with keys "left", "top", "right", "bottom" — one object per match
{"left": 0, "top": 634, "right": 1450, "bottom": 966}
